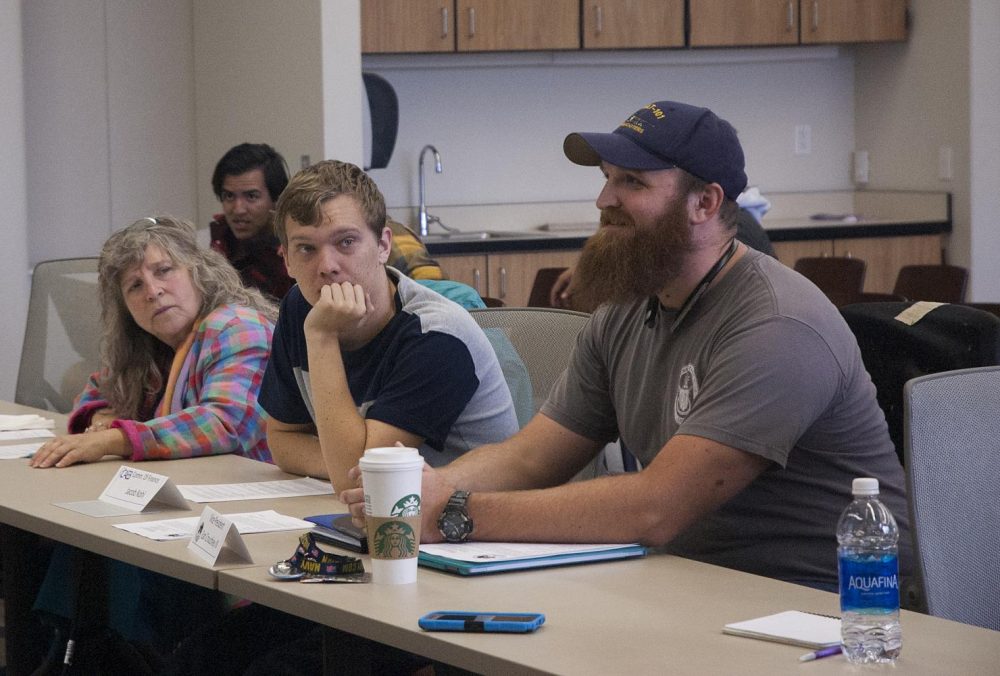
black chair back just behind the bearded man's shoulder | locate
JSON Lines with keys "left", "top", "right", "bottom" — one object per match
{"left": 840, "top": 302, "right": 1000, "bottom": 460}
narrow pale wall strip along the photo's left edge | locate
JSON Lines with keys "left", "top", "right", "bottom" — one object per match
{"left": 0, "top": 0, "right": 28, "bottom": 401}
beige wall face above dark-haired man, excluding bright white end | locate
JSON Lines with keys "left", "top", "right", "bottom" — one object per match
{"left": 194, "top": 0, "right": 323, "bottom": 226}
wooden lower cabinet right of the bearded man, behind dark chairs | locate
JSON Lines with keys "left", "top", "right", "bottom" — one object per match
{"left": 774, "top": 235, "right": 942, "bottom": 293}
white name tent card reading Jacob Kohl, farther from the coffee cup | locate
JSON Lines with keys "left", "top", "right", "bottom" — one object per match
{"left": 54, "top": 465, "right": 191, "bottom": 516}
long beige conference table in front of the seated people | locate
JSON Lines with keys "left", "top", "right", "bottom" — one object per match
{"left": 0, "top": 402, "right": 1000, "bottom": 675}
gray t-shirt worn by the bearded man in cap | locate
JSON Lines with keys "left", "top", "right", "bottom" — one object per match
{"left": 542, "top": 250, "right": 910, "bottom": 584}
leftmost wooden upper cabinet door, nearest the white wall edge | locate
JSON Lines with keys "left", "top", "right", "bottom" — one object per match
{"left": 361, "top": 0, "right": 455, "bottom": 54}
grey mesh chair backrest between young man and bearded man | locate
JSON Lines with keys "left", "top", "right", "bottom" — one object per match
{"left": 469, "top": 307, "right": 590, "bottom": 413}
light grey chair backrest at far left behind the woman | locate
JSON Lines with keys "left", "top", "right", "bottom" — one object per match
{"left": 14, "top": 258, "right": 101, "bottom": 413}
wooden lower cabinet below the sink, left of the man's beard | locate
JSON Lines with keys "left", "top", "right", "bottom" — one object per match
{"left": 434, "top": 250, "right": 580, "bottom": 307}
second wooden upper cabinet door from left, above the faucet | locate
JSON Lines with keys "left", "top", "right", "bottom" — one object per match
{"left": 455, "top": 0, "right": 580, "bottom": 52}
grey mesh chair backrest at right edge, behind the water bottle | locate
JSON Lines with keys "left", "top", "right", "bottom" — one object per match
{"left": 905, "top": 367, "right": 1000, "bottom": 630}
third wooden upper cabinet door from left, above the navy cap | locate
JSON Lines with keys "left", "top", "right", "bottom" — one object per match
{"left": 582, "top": 0, "right": 684, "bottom": 49}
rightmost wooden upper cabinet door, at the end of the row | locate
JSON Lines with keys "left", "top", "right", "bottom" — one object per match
{"left": 800, "top": 0, "right": 906, "bottom": 44}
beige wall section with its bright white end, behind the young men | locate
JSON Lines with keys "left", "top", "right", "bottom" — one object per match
{"left": 194, "top": 0, "right": 362, "bottom": 225}
